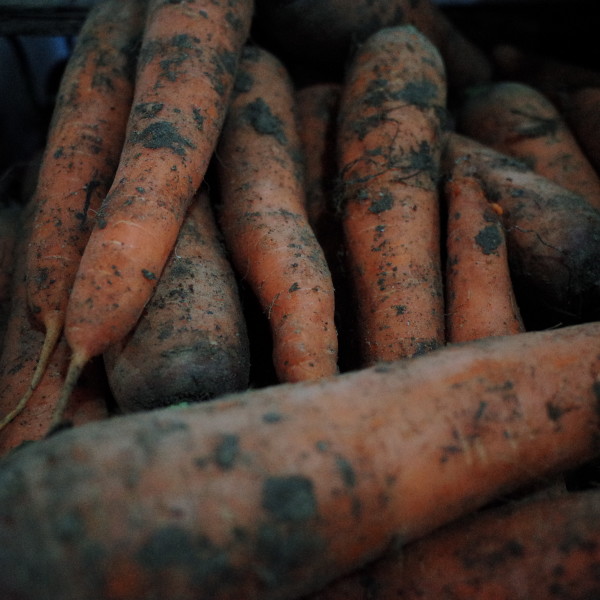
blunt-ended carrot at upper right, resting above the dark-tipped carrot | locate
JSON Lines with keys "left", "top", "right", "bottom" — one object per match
{"left": 457, "top": 81, "right": 600, "bottom": 208}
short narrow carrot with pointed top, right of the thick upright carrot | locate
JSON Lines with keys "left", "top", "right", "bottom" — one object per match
{"left": 444, "top": 163, "right": 524, "bottom": 342}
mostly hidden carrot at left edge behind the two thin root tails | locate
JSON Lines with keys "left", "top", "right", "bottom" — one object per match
{"left": 0, "top": 205, "right": 108, "bottom": 456}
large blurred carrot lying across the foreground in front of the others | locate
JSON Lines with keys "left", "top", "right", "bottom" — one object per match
{"left": 0, "top": 323, "right": 600, "bottom": 600}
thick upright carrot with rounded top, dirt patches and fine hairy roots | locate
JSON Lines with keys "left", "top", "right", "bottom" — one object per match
{"left": 337, "top": 26, "right": 446, "bottom": 366}
